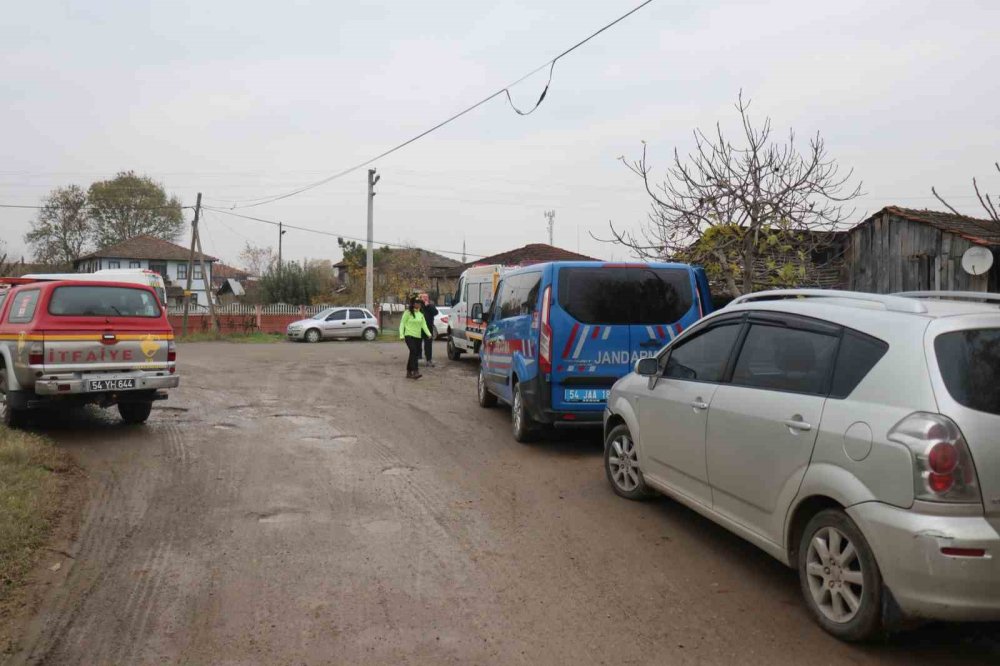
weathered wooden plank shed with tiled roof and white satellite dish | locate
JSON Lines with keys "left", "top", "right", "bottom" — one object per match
{"left": 847, "top": 206, "right": 1000, "bottom": 294}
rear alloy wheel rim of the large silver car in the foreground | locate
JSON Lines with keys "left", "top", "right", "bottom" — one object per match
{"left": 806, "top": 527, "right": 865, "bottom": 624}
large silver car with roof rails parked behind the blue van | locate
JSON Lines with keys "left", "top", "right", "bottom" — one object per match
{"left": 604, "top": 290, "right": 1000, "bottom": 641}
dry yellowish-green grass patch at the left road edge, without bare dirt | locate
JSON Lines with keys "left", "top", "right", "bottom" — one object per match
{"left": 0, "top": 426, "right": 70, "bottom": 601}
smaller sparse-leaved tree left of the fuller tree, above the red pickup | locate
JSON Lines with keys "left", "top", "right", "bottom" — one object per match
{"left": 24, "top": 185, "right": 91, "bottom": 267}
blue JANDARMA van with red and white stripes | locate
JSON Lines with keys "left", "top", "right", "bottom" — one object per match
{"left": 472, "top": 261, "right": 712, "bottom": 442}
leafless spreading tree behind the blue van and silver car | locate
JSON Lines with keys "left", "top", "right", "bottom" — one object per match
{"left": 610, "top": 92, "right": 861, "bottom": 296}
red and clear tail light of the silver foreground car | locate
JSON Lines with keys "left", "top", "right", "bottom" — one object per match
{"left": 889, "top": 412, "right": 982, "bottom": 502}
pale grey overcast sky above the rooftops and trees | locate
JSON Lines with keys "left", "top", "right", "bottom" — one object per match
{"left": 0, "top": 0, "right": 1000, "bottom": 262}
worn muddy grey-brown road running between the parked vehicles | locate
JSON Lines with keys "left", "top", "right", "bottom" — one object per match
{"left": 3, "top": 342, "right": 1000, "bottom": 665}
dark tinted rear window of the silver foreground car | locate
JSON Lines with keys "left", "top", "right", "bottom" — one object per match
{"left": 934, "top": 328, "right": 1000, "bottom": 414}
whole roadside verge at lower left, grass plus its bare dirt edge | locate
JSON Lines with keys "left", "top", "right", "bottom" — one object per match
{"left": 0, "top": 426, "right": 83, "bottom": 658}
